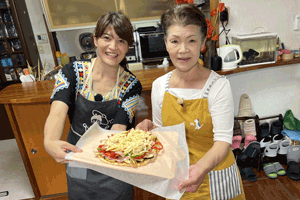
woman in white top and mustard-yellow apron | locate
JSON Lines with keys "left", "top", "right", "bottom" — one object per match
{"left": 137, "top": 4, "right": 245, "bottom": 200}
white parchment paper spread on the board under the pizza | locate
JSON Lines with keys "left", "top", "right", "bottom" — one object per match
{"left": 66, "top": 123, "right": 189, "bottom": 199}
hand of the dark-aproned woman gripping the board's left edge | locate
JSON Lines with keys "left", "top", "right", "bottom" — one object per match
{"left": 44, "top": 140, "right": 82, "bottom": 164}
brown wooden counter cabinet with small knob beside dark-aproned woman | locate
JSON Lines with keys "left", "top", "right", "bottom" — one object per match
{"left": 0, "top": 80, "right": 70, "bottom": 199}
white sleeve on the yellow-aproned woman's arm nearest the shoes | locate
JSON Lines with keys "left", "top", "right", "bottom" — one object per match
{"left": 208, "top": 78, "right": 234, "bottom": 144}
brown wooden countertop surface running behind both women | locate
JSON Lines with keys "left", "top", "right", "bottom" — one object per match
{"left": 0, "top": 58, "right": 300, "bottom": 104}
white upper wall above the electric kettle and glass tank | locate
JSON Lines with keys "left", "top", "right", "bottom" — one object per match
{"left": 220, "top": 0, "right": 300, "bottom": 49}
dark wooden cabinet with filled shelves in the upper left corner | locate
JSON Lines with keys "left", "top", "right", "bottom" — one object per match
{"left": 0, "top": 0, "right": 39, "bottom": 87}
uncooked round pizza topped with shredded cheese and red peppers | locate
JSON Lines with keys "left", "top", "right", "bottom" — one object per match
{"left": 95, "top": 129, "right": 163, "bottom": 167}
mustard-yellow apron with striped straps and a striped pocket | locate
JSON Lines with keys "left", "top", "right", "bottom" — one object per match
{"left": 162, "top": 73, "right": 245, "bottom": 200}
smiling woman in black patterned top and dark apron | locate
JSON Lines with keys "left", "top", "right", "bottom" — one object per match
{"left": 44, "top": 12, "right": 142, "bottom": 200}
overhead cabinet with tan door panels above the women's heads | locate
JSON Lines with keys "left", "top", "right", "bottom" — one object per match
{"left": 41, "top": 0, "right": 212, "bottom": 31}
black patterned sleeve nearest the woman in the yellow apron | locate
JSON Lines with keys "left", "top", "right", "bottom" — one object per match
{"left": 113, "top": 79, "right": 142, "bottom": 126}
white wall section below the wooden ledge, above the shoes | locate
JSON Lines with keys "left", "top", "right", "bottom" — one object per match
{"left": 227, "top": 64, "right": 300, "bottom": 119}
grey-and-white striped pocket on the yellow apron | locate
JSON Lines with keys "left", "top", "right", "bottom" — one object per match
{"left": 208, "top": 163, "right": 242, "bottom": 200}
